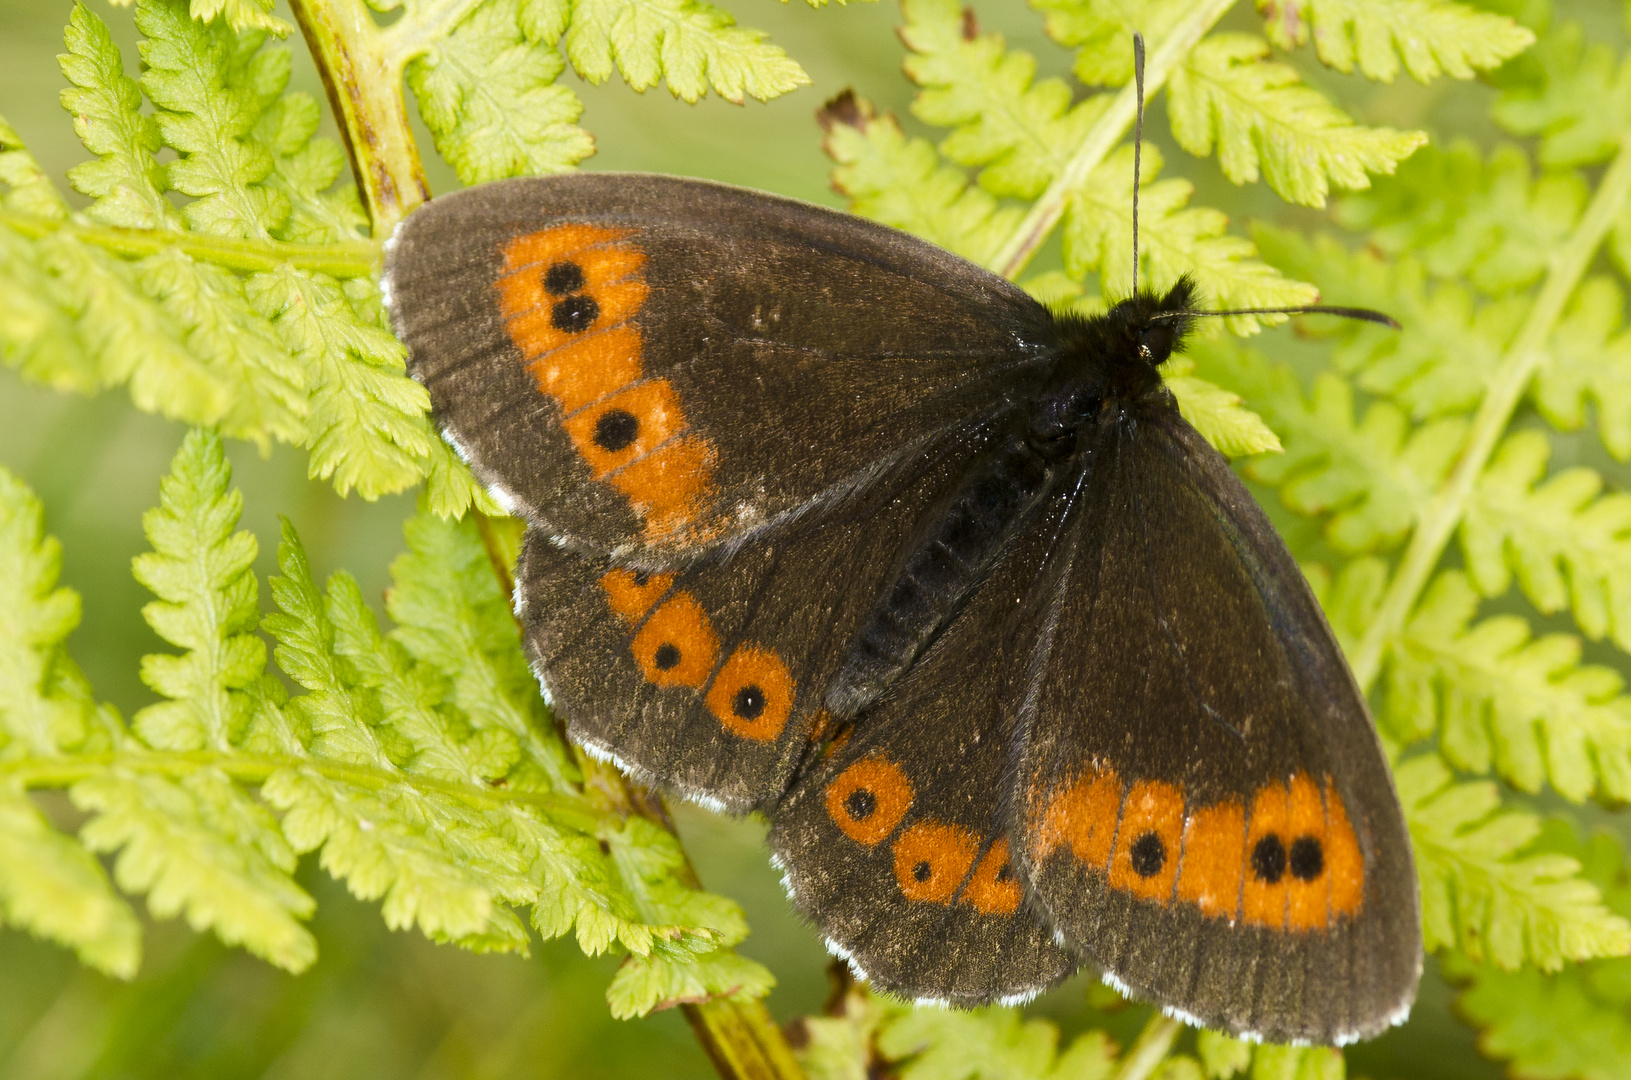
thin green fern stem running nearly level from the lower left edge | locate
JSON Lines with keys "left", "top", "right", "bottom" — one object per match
{"left": 0, "top": 750, "right": 602, "bottom": 835}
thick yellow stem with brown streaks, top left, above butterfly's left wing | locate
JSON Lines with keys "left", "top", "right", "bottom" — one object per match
{"left": 289, "top": 0, "right": 431, "bottom": 237}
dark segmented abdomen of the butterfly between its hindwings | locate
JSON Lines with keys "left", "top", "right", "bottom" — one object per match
{"left": 827, "top": 436, "right": 1062, "bottom": 716}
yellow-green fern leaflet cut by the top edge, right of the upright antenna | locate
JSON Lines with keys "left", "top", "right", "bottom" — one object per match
{"left": 1258, "top": 0, "right": 1535, "bottom": 83}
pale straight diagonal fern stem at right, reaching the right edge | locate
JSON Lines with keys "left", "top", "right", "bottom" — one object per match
{"left": 1352, "top": 135, "right": 1631, "bottom": 693}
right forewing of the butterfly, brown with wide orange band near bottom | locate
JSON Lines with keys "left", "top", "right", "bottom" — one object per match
{"left": 1011, "top": 414, "right": 1421, "bottom": 1042}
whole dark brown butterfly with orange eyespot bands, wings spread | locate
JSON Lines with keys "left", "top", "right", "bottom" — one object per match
{"left": 385, "top": 152, "right": 1421, "bottom": 1042}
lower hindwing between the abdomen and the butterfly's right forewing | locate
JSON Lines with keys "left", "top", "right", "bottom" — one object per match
{"left": 770, "top": 509, "right": 1080, "bottom": 1005}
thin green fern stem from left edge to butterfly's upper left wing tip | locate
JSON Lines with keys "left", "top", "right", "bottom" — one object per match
{"left": 0, "top": 210, "right": 380, "bottom": 277}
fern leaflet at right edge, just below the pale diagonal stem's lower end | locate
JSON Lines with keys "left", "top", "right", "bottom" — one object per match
{"left": 1385, "top": 571, "right": 1631, "bottom": 803}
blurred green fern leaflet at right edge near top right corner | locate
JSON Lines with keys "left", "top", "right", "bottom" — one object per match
{"left": 1491, "top": 23, "right": 1631, "bottom": 165}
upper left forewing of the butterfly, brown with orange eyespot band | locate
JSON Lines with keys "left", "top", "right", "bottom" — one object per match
{"left": 385, "top": 175, "right": 1047, "bottom": 564}
